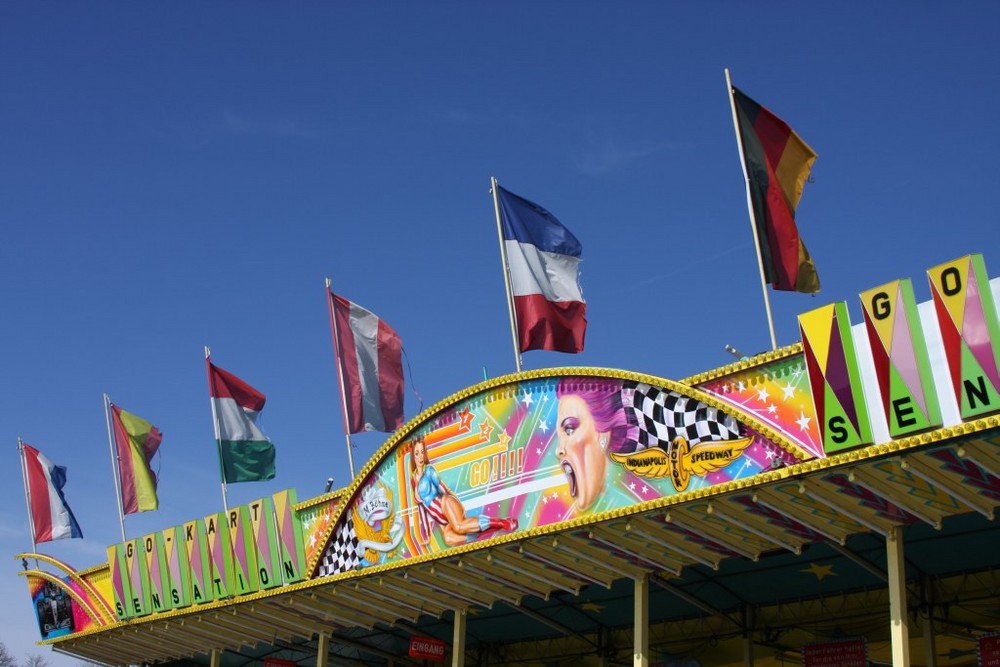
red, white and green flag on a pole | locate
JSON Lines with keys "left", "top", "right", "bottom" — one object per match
{"left": 205, "top": 359, "right": 274, "bottom": 484}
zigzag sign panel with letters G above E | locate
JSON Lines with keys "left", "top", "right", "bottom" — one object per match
{"left": 860, "top": 279, "right": 941, "bottom": 438}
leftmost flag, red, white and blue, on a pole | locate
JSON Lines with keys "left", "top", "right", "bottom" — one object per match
{"left": 21, "top": 443, "right": 83, "bottom": 544}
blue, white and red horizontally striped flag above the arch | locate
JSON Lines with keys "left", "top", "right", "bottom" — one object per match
{"left": 496, "top": 185, "right": 587, "bottom": 354}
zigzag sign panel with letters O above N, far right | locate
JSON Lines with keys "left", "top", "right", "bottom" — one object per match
{"left": 927, "top": 254, "right": 1000, "bottom": 420}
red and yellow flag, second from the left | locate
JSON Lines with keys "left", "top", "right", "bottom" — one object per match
{"left": 111, "top": 404, "right": 163, "bottom": 514}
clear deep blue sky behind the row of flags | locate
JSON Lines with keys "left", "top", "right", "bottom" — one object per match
{"left": 0, "top": 0, "right": 1000, "bottom": 665}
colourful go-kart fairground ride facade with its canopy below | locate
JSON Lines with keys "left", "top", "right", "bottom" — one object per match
{"left": 16, "top": 255, "right": 1000, "bottom": 667}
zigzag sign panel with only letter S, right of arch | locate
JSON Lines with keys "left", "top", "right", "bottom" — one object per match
{"left": 799, "top": 301, "right": 872, "bottom": 454}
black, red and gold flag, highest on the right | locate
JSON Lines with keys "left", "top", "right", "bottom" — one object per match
{"left": 733, "top": 87, "right": 819, "bottom": 294}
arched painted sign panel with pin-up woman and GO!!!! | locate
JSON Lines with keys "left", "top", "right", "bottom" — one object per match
{"left": 309, "top": 369, "right": 808, "bottom": 576}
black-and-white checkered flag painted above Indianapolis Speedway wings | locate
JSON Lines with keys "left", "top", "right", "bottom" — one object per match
{"left": 623, "top": 383, "right": 740, "bottom": 450}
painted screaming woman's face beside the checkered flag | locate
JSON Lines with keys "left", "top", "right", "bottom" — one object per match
{"left": 556, "top": 394, "right": 607, "bottom": 510}
